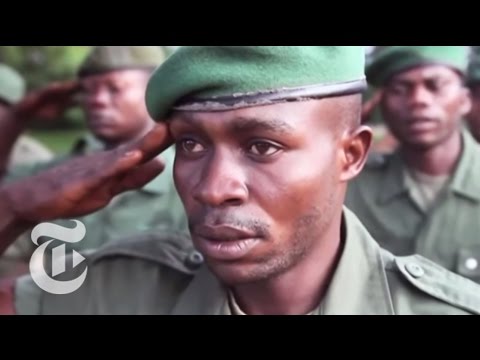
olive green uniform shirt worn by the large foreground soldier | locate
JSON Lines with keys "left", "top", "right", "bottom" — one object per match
{"left": 15, "top": 209, "right": 480, "bottom": 315}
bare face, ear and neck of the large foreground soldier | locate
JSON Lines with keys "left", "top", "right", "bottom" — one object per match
{"left": 170, "top": 96, "right": 372, "bottom": 314}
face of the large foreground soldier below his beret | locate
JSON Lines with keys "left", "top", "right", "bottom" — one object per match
{"left": 170, "top": 99, "right": 368, "bottom": 284}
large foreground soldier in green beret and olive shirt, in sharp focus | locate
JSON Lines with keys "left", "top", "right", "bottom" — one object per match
{"left": 4, "top": 46, "right": 480, "bottom": 315}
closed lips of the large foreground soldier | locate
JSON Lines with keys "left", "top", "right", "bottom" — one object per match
{"left": 193, "top": 226, "right": 262, "bottom": 261}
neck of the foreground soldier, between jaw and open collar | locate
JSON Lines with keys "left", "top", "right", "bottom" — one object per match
{"left": 233, "top": 214, "right": 341, "bottom": 315}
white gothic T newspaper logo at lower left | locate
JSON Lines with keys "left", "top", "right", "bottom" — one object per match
{"left": 29, "top": 220, "right": 87, "bottom": 295}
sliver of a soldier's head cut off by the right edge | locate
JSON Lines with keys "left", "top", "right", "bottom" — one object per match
{"left": 466, "top": 46, "right": 480, "bottom": 142}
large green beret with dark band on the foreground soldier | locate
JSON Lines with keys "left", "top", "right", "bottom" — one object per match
{"left": 146, "top": 46, "right": 366, "bottom": 120}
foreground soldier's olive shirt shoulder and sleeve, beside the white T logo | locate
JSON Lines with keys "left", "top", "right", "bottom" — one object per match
{"left": 14, "top": 232, "right": 203, "bottom": 315}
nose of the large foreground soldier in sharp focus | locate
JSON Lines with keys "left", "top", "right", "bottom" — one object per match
{"left": 193, "top": 147, "right": 248, "bottom": 207}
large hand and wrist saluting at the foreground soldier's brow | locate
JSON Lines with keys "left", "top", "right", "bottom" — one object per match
{"left": 0, "top": 124, "right": 172, "bottom": 223}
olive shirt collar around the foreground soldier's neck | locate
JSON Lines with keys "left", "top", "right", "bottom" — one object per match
{"left": 173, "top": 208, "right": 393, "bottom": 315}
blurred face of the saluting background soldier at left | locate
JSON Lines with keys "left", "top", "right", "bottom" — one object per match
{"left": 80, "top": 70, "right": 151, "bottom": 143}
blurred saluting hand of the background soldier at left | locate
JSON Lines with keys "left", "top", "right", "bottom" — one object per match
{"left": 14, "top": 81, "right": 80, "bottom": 121}
